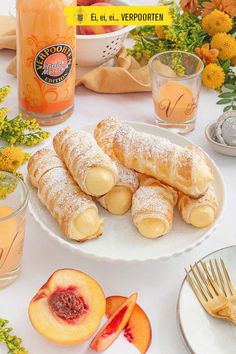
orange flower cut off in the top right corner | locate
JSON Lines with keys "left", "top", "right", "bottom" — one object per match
{"left": 202, "top": 0, "right": 236, "bottom": 17}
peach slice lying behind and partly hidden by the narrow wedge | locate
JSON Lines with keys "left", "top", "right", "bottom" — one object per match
{"left": 106, "top": 296, "right": 152, "bottom": 354}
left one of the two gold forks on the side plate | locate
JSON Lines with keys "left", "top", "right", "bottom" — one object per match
{"left": 185, "top": 261, "right": 236, "bottom": 325}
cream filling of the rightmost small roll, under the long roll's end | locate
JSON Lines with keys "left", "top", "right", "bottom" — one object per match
{"left": 189, "top": 205, "right": 215, "bottom": 227}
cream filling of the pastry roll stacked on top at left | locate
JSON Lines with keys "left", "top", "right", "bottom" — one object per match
{"left": 85, "top": 167, "right": 115, "bottom": 197}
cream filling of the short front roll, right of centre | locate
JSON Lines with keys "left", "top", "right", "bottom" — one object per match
{"left": 137, "top": 218, "right": 166, "bottom": 238}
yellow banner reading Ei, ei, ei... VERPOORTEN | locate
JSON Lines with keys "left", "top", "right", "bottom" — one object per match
{"left": 65, "top": 6, "right": 171, "bottom": 26}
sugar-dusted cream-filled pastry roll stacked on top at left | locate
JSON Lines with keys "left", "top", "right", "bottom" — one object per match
{"left": 53, "top": 127, "right": 118, "bottom": 197}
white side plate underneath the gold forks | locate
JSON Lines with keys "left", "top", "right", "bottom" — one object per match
{"left": 177, "top": 246, "right": 236, "bottom": 354}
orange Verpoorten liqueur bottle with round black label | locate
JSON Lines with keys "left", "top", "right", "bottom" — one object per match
{"left": 16, "top": 0, "right": 76, "bottom": 125}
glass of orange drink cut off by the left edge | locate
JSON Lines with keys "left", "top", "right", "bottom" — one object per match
{"left": 0, "top": 171, "right": 29, "bottom": 288}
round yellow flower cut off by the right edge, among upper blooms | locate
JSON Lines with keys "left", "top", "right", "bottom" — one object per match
{"left": 211, "top": 33, "right": 236, "bottom": 60}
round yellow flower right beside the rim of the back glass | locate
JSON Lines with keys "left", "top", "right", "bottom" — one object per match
{"left": 202, "top": 64, "right": 225, "bottom": 89}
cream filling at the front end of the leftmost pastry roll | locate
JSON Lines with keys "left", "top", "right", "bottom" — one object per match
{"left": 71, "top": 208, "right": 101, "bottom": 241}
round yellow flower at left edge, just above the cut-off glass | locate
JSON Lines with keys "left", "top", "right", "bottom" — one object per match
{"left": 0, "top": 146, "right": 28, "bottom": 172}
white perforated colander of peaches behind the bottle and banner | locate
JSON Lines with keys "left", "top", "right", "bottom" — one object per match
{"left": 76, "top": 0, "right": 134, "bottom": 67}
